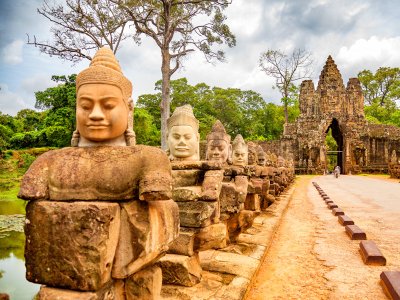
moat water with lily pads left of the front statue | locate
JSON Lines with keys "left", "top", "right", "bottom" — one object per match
{"left": 0, "top": 200, "right": 40, "bottom": 300}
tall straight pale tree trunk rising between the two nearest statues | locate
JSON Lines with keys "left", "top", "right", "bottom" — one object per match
{"left": 160, "top": 49, "right": 171, "bottom": 150}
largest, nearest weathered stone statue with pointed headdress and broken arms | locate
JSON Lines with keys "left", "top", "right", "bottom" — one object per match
{"left": 18, "top": 48, "right": 179, "bottom": 299}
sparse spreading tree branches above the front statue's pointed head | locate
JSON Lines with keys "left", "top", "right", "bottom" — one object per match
{"left": 27, "top": 0, "right": 128, "bottom": 63}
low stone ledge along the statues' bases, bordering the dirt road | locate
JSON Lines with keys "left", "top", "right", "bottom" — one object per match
{"left": 161, "top": 180, "right": 296, "bottom": 300}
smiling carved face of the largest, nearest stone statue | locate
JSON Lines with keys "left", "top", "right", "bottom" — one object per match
{"left": 76, "top": 83, "right": 128, "bottom": 142}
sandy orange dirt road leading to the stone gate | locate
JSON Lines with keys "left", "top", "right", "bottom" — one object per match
{"left": 246, "top": 176, "right": 400, "bottom": 300}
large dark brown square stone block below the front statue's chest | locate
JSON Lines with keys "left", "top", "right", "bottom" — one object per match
{"left": 25, "top": 201, "right": 120, "bottom": 291}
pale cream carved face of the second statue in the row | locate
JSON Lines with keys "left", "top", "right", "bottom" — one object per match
{"left": 167, "top": 125, "right": 199, "bottom": 160}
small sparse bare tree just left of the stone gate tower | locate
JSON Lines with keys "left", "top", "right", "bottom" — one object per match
{"left": 259, "top": 49, "right": 313, "bottom": 123}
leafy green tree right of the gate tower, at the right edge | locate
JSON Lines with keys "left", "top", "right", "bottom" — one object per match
{"left": 358, "top": 67, "right": 400, "bottom": 107}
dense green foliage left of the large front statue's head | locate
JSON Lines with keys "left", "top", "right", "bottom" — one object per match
{"left": 0, "top": 74, "right": 76, "bottom": 152}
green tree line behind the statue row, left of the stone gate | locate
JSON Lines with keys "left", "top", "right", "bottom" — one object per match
{"left": 135, "top": 78, "right": 299, "bottom": 140}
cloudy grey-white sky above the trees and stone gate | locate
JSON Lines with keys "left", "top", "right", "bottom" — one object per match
{"left": 0, "top": 0, "right": 400, "bottom": 115}
